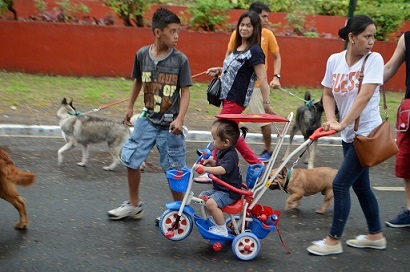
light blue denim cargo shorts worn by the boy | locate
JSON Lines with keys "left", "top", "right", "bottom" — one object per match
{"left": 121, "top": 118, "right": 186, "bottom": 172}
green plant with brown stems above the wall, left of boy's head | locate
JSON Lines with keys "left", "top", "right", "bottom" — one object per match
{"left": 102, "top": 0, "right": 150, "bottom": 27}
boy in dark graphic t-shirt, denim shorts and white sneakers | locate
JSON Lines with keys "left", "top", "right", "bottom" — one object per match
{"left": 108, "top": 8, "right": 192, "bottom": 219}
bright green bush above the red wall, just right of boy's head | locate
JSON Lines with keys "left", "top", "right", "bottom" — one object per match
{"left": 188, "top": 0, "right": 232, "bottom": 31}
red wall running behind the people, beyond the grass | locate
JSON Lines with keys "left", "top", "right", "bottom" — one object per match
{"left": 0, "top": 0, "right": 405, "bottom": 90}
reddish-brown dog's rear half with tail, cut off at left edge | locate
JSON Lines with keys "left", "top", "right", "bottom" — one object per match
{"left": 0, "top": 148, "right": 35, "bottom": 229}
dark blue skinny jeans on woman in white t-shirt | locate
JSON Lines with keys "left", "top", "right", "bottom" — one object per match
{"left": 329, "top": 141, "right": 382, "bottom": 239}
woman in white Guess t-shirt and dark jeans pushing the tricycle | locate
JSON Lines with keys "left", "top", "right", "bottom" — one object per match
{"left": 307, "top": 15, "right": 387, "bottom": 255}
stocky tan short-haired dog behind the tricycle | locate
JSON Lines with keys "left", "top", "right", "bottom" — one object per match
{"left": 269, "top": 167, "right": 337, "bottom": 214}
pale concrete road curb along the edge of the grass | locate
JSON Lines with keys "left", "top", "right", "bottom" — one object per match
{"left": 0, "top": 124, "right": 341, "bottom": 144}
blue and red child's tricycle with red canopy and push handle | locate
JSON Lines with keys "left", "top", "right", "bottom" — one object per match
{"left": 159, "top": 113, "right": 335, "bottom": 261}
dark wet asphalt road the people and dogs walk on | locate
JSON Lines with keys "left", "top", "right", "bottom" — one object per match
{"left": 0, "top": 126, "right": 410, "bottom": 271}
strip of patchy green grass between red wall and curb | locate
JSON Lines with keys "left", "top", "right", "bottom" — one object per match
{"left": 0, "top": 72, "right": 404, "bottom": 123}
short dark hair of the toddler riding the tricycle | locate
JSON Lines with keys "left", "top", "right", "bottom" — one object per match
{"left": 212, "top": 119, "right": 248, "bottom": 145}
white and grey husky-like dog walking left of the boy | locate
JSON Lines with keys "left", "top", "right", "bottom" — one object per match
{"left": 57, "top": 98, "right": 131, "bottom": 170}
